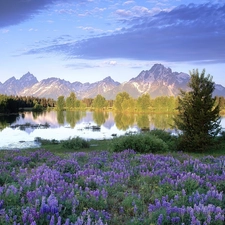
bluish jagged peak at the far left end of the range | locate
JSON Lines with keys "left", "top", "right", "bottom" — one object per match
{"left": 0, "top": 72, "right": 38, "bottom": 95}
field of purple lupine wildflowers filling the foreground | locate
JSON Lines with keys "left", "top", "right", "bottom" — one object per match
{"left": 0, "top": 150, "right": 225, "bottom": 225}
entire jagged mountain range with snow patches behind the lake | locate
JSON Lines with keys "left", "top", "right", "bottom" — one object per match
{"left": 0, "top": 64, "right": 225, "bottom": 99}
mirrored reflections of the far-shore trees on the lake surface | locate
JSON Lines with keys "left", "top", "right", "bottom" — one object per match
{"left": 0, "top": 110, "right": 177, "bottom": 131}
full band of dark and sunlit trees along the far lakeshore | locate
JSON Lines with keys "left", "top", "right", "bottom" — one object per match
{"left": 0, "top": 92, "right": 225, "bottom": 114}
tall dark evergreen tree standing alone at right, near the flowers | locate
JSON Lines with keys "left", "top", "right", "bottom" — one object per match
{"left": 174, "top": 70, "right": 221, "bottom": 151}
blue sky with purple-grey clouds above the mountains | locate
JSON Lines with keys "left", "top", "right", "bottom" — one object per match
{"left": 0, "top": 0, "right": 225, "bottom": 86}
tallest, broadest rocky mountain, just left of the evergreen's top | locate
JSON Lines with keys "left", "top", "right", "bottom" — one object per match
{"left": 105, "top": 64, "right": 190, "bottom": 98}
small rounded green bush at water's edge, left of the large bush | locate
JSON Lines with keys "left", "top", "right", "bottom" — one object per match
{"left": 61, "top": 137, "right": 90, "bottom": 150}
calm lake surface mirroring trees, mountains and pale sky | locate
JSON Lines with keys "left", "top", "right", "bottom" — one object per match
{"left": 0, "top": 111, "right": 225, "bottom": 149}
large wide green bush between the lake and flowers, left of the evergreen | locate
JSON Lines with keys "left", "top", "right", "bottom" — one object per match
{"left": 110, "top": 134, "right": 169, "bottom": 153}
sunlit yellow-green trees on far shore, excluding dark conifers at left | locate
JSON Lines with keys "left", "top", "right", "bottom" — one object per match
{"left": 56, "top": 92, "right": 225, "bottom": 113}
